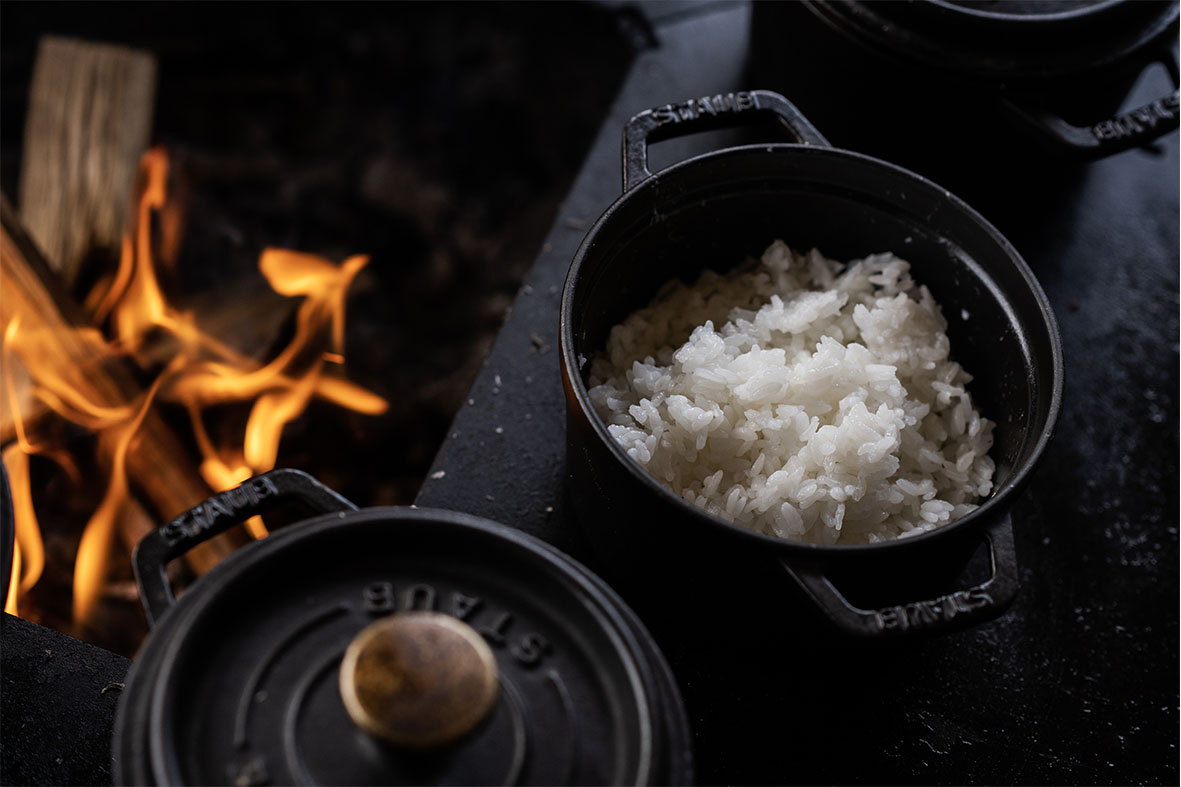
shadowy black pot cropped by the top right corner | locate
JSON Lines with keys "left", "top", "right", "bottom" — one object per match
{"left": 749, "top": 0, "right": 1181, "bottom": 230}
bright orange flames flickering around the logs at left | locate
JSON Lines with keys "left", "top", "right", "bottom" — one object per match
{"left": 2, "top": 148, "right": 389, "bottom": 622}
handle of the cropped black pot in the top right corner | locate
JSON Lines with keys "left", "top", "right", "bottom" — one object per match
{"left": 1000, "top": 51, "right": 1181, "bottom": 158}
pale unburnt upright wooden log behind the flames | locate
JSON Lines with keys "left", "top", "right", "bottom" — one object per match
{"left": 19, "top": 35, "right": 156, "bottom": 285}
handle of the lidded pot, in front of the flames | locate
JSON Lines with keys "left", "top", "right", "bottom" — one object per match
{"left": 132, "top": 469, "right": 357, "bottom": 625}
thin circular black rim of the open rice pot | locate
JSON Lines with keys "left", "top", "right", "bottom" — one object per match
{"left": 559, "top": 143, "right": 1064, "bottom": 562}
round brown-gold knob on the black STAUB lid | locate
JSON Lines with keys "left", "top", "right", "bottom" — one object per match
{"left": 340, "top": 612, "right": 500, "bottom": 748}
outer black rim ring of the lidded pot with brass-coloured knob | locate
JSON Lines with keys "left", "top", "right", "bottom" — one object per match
{"left": 131, "top": 506, "right": 687, "bottom": 783}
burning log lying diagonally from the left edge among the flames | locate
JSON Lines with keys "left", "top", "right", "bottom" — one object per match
{"left": 0, "top": 197, "right": 239, "bottom": 573}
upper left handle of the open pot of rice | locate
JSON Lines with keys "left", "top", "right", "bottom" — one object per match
{"left": 624, "top": 90, "right": 831, "bottom": 191}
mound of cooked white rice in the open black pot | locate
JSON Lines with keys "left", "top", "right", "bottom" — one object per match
{"left": 589, "top": 241, "right": 994, "bottom": 544}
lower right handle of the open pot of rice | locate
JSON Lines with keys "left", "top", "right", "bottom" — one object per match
{"left": 783, "top": 515, "right": 1018, "bottom": 639}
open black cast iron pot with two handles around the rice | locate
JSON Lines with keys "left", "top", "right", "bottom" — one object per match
{"left": 561, "top": 91, "right": 1063, "bottom": 637}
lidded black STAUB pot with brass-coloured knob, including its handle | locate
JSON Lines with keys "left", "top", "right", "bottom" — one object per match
{"left": 113, "top": 470, "right": 691, "bottom": 785}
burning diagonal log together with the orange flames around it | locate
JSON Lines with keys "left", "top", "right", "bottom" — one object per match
{"left": 0, "top": 142, "right": 387, "bottom": 622}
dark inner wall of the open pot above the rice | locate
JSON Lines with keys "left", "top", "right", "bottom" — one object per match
{"left": 570, "top": 147, "right": 1055, "bottom": 494}
